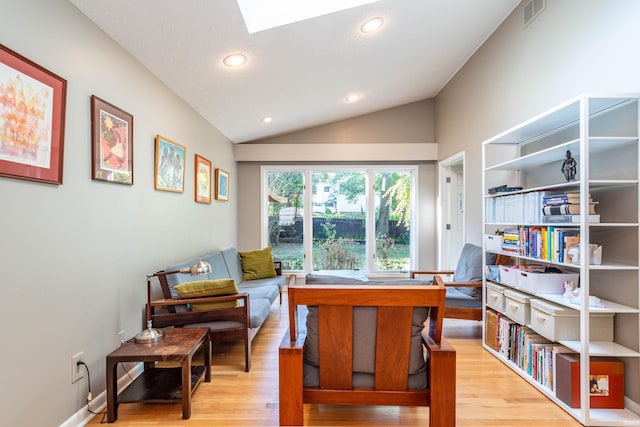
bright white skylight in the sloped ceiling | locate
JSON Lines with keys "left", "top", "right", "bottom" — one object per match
{"left": 236, "top": 0, "right": 378, "bottom": 34}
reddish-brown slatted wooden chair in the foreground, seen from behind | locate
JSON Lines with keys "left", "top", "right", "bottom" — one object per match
{"left": 279, "top": 276, "right": 456, "bottom": 427}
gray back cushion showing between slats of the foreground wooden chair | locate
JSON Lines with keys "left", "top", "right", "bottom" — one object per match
{"left": 304, "top": 306, "right": 429, "bottom": 374}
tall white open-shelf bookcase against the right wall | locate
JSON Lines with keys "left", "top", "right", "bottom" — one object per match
{"left": 482, "top": 94, "right": 640, "bottom": 426}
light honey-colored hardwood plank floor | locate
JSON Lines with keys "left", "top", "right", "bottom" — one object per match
{"left": 89, "top": 298, "right": 581, "bottom": 427}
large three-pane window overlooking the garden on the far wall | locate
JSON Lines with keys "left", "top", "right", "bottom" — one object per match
{"left": 262, "top": 166, "right": 417, "bottom": 272}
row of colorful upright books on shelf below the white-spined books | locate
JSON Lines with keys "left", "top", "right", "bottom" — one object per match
{"left": 502, "top": 226, "right": 580, "bottom": 262}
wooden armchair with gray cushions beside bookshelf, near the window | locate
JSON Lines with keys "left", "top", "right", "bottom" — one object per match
{"left": 410, "top": 244, "right": 511, "bottom": 320}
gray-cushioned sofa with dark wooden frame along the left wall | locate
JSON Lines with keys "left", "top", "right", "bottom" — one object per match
{"left": 154, "top": 248, "right": 286, "bottom": 372}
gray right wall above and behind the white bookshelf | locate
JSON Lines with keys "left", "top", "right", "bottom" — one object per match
{"left": 436, "top": 0, "right": 640, "bottom": 244}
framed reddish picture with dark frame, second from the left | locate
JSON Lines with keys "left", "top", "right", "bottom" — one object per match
{"left": 91, "top": 95, "right": 133, "bottom": 185}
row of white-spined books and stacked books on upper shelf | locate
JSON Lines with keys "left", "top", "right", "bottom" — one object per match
{"left": 485, "top": 191, "right": 600, "bottom": 224}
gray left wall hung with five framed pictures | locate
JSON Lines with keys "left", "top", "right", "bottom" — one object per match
{"left": 0, "top": 0, "right": 237, "bottom": 426}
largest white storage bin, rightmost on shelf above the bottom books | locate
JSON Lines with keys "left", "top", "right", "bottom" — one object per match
{"left": 529, "top": 298, "right": 613, "bottom": 341}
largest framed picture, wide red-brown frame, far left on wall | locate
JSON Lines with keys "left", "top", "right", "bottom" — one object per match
{"left": 0, "top": 44, "right": 67, "bottom": 184}
